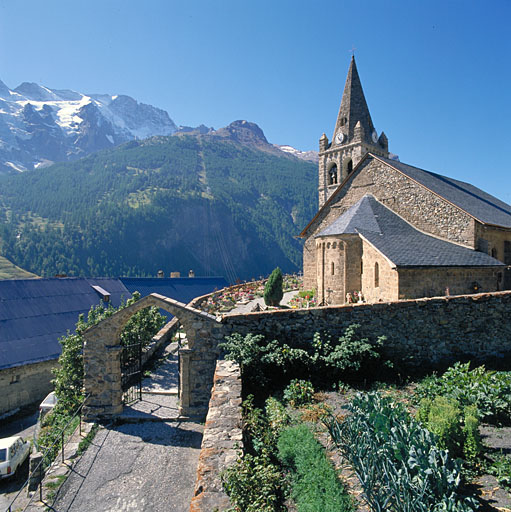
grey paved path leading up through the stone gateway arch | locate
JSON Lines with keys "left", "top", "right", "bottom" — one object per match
{"left": 52, "top": 344, "right": 203, "bottom": 512}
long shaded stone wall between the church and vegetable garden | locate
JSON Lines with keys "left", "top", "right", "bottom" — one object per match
{"left": 222, "top": 292, "right": 511, "bottom": 366}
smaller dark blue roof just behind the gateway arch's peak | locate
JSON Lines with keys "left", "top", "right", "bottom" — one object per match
{"left": 119, "top": 277, "right": 229, "bottom": 319}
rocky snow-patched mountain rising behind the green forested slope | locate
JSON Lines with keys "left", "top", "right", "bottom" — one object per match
{"left": 0, "top": 81, "right": 177, "bottom": 172}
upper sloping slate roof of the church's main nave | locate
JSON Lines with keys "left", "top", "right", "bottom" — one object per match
{"left": 372, "top": 155, "right": 511, "bottom": 228}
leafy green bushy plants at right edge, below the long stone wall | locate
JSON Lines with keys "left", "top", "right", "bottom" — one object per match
{"left": 415, "top": 363, "right": 511, "bottom": 422}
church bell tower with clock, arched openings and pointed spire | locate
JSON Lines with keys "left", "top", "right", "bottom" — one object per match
{"left": 318, "top": 56, "right": 389, "bottom": 208}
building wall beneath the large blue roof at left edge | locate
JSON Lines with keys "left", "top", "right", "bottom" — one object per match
{"left": 0, "top": 359, "right": 57, "bottom": 415}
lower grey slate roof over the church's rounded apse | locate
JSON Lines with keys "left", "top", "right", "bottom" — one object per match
{"left": 316, "top": 194, "right": 504, "bottom": 267}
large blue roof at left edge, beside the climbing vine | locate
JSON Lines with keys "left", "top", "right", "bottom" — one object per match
{"left": 0, "top": 278, "right": 131, "bottom": 369}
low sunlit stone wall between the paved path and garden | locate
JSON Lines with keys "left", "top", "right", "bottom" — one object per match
{"left": 190, "top": 360, "right": 242, "bottom": 512}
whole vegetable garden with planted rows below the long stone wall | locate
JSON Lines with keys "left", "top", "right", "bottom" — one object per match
{"left": 222, "top": 325, "right": 511, "bottom": 512}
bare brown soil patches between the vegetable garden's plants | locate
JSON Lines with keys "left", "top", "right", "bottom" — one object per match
{"left": 315, "top": 385, "right": 511, "bottom": 512}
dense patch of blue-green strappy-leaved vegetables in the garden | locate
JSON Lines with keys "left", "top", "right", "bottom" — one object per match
{"left": 325, "top": 392, "right": 475, "bottom": 512}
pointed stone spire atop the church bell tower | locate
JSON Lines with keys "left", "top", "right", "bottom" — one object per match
{"left": 333, "top": 55, "right": 374, "bottom": 144}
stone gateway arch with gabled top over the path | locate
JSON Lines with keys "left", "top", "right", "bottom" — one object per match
{"left": 83, "top": 293, "right": 226, "bottom": 420}
